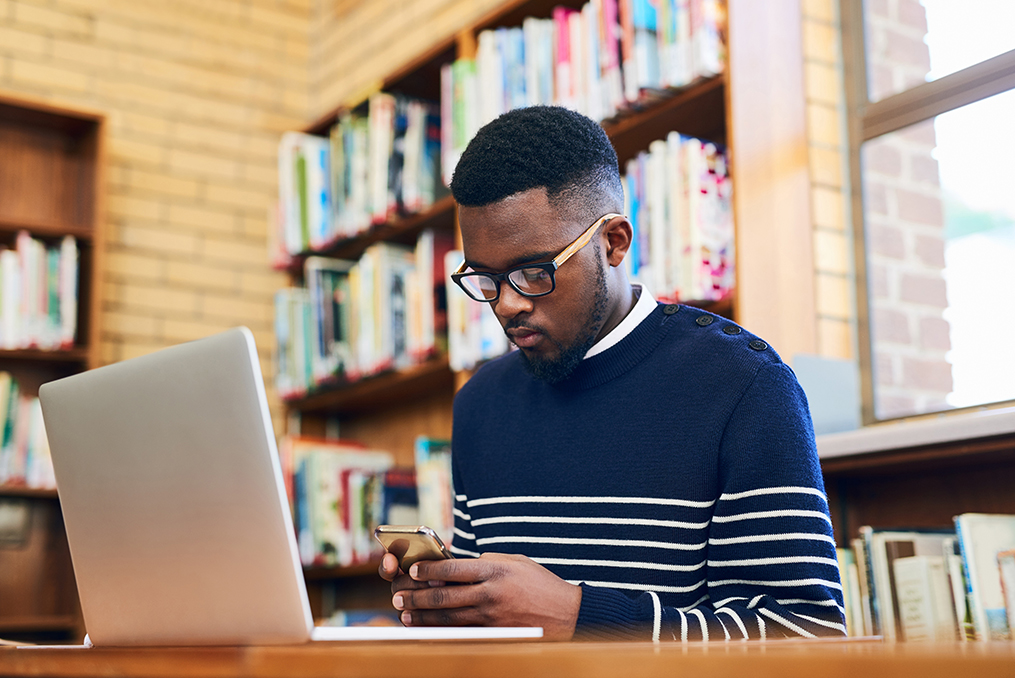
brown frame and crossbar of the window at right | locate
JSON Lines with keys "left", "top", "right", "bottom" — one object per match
{"left": 839, "top": 0, "right": 1015, "bottom": 425}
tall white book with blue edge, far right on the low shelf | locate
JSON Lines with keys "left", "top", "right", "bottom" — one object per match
{"left": 955, "top": 514, "right": 1015, "bottom": 640}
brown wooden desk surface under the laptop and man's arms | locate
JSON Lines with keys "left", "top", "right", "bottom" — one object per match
{"left": 0, "top": 640, "right": 1015, "bottom": 678}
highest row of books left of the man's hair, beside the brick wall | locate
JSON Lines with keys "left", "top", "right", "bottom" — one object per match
{"left": 273, "top": 92, "right": 447, "bottom": 266}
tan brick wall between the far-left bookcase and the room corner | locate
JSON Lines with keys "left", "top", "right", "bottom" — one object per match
{"left": 0, "top": 0, "right": 313, "bottom": 432}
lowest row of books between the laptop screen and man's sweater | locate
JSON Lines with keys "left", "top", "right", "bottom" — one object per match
{"left": 279, "top": 436, "right": 454, "bottom": 567}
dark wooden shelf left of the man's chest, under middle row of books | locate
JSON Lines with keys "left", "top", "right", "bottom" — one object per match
{"left": 285, "top": 356, "right": 455, "bottom": 414}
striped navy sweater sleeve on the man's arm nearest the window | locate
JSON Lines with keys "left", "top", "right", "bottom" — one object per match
{"left": 578, "top": 362, "right": 845, "bottom": 641}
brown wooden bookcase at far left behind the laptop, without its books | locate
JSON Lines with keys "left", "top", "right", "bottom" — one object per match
{"left": 0, "top": 94, "right": 106, "bottom": 641}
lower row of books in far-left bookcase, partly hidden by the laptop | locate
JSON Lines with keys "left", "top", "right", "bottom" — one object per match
{"left": 0, "top": 371, "right": 57, "bottom": 489}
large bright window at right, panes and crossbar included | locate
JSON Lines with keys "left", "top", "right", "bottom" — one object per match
{"left": 841, "top": 0, "right": 1015, "bottom": 423}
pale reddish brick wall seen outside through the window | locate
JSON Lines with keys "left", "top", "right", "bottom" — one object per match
{"left": 863, "top": 0, "right": 952, "bottom": 418}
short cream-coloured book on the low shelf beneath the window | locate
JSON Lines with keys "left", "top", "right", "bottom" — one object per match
{"left": 892, "top": 555, "right": 956, "bottom": 642}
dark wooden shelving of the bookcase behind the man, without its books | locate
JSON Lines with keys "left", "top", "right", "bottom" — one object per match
{"left": 285, "top": 0, "right": 737, "bottom": 615}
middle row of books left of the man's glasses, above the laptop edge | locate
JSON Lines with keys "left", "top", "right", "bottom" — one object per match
{"left": 275, "top": 229, "right": 452, "bottom": 399}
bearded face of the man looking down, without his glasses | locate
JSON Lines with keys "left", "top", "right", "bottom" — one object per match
{"left": 459, "top": 189, "right": 607, "bottom": 383}
